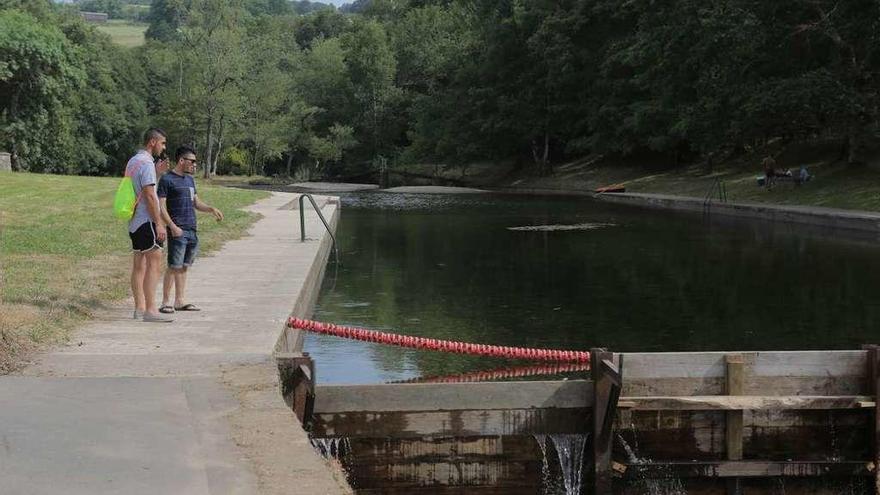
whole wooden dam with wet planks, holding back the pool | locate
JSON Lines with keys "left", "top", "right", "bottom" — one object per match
{"left": 276, "top": 318, "right": 880, "bottom": 495}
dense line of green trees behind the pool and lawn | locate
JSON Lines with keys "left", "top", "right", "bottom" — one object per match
{"left": 0, "top": 0, "right": 880, "bottom": 177}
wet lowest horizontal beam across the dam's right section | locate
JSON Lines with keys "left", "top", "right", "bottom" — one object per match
{"left": 625, "top": 461, "right": 871, "bottom": 479}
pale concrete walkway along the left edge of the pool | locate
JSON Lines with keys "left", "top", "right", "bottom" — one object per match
{"left": 0, "top": 193, "right": 350, "bottom": 495}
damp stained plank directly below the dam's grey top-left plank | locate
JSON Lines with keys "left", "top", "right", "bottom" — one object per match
{"left": 311, "top": 408, "right": 588, "bottom": 438}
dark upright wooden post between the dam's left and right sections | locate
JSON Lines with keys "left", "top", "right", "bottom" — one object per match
{"left": 590, "top": 348, "right": 623, "bottom": 495}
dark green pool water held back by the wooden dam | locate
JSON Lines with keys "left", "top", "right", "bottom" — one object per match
{"left": 306, "top": 193, "right": 880, "bottom": 383}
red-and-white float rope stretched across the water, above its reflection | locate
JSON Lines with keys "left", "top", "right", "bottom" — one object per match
{"left": 287, "top": 318, "right": 590, "bottom": 363}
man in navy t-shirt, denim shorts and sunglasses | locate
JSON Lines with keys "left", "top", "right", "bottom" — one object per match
{"left": 158, "top": 146, "right": 223, "bottom": 313}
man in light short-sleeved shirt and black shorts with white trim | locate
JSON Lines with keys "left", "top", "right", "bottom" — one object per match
{"left": 125, "top": 128, "right": 173, "bottom": 323}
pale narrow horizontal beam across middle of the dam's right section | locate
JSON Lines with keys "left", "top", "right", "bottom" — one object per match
{"left": 620, "top": 395, "right": 875, "bottom": 411}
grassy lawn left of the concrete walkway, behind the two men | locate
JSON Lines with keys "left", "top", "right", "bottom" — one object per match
{"left": 0, "top": 172, "right": 268, "bottom": 373}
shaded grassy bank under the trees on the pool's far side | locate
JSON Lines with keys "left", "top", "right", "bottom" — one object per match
{"left": 422, "top": 148, "right": 880, "bottom": 211}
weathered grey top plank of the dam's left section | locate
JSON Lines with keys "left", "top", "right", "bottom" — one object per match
{"left": 315, "top": 380, "right": 593, "bottom": 414}
